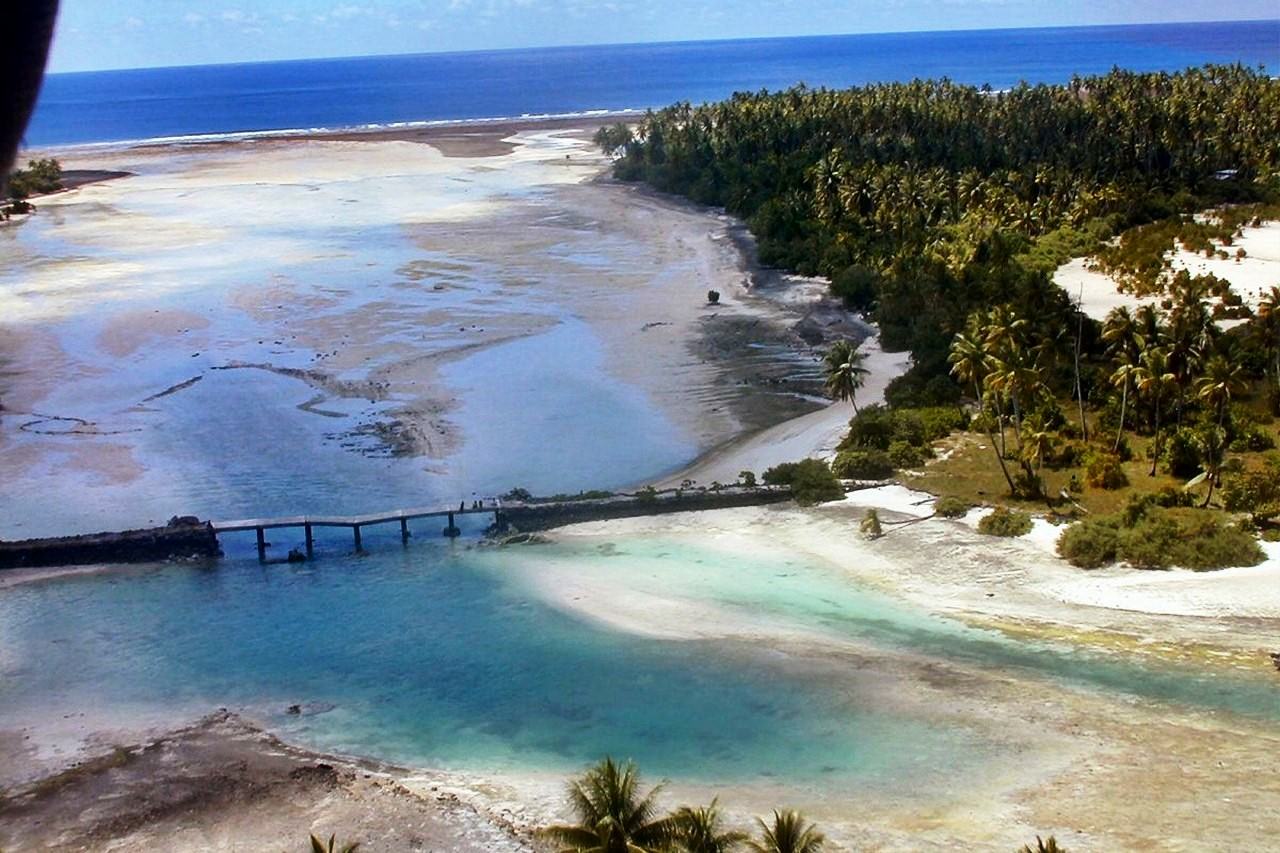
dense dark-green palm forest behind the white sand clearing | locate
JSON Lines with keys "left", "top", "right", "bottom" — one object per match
{"left": 598, "top": 67, "right": 1280, "bottom": 391}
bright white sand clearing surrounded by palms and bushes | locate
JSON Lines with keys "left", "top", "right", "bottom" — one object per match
{"left": 1053, "top": 216, "right": 1280, "bottom": 318}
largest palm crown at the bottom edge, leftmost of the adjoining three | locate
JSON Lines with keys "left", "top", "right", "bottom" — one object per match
{"left": 543, "top": 758, "right": 673, "bottom": 853}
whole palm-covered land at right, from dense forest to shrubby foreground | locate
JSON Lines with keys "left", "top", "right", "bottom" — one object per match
{"left": 596, "top": 65, "right": 1280, "bottom": 569}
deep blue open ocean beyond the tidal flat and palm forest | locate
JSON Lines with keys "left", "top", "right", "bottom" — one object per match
{"left": 27, "top": 20, "right": 1280, "bottom": 146}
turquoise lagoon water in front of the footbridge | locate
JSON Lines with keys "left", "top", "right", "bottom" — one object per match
{"left": 0, "top": 530, "right": 1280, "bottom": 790}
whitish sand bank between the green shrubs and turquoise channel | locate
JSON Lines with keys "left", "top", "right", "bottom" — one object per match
{"left": 548, "top": 485, "right": 1280, "bottom": 645}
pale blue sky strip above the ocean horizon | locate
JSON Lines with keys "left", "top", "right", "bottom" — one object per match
{"left": 49, "top": 0, "right": 1280, "bottom": 72}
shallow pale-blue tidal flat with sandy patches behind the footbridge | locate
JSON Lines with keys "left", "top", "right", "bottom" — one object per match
{"left": 0, "top": 131, "right": 812, "bottom": 538}
